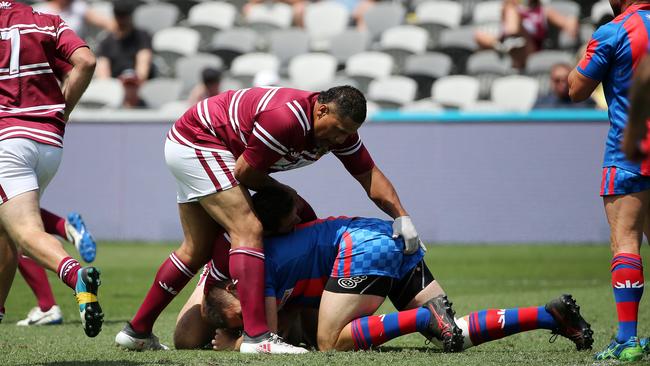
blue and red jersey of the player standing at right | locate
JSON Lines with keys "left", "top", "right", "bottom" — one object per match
{"left": 577, "top": 3, "right": 650, "bottom": 175}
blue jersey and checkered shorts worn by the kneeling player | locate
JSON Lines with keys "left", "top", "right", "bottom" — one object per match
{"left": 264, "top": 217, "right": 424, "bottom": 309}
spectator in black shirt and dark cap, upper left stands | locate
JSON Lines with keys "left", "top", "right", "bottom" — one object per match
{"left": 96, "top": 0, "right": 153, "bottom": 107}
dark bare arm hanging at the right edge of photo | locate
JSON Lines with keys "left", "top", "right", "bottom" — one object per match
{"left": 622, "top": 57, "right": 650, "bottom": 161}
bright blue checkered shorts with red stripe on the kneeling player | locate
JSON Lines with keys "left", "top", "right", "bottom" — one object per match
{"left": 330, "top": 219, "right": 424, "bottom": 279}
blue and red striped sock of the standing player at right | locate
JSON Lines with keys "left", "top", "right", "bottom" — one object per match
{"left": 611, "top": 253, "right": 643, "bottom": 342}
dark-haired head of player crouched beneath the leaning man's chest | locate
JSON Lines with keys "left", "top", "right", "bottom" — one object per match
{"left": 253, "top": 187, "right": 300, "bottom": 235}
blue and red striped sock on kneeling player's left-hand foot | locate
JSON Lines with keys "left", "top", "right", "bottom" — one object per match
{"left": 350, "top": 308, "right": 431, "bottom": 349}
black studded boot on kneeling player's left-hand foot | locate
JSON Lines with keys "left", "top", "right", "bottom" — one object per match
{"left": 422, "top": 295, "right": 464, "bottom": 352}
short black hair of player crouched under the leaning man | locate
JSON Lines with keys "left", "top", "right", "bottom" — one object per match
{"left": 252, "top": 187, "right": 296, "bottom": 233}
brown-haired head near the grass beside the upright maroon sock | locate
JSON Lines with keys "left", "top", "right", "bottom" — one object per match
{"left": 201, "top": 280, "right": 244, "bottom": 330}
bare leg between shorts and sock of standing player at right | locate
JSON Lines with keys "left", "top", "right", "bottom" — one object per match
{"left": 603, "top": 190, "right": 650, "bottom": 252}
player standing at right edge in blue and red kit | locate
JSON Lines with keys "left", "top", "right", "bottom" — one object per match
{"left": 569, "top": 0, "right": 650, "bottom": 361}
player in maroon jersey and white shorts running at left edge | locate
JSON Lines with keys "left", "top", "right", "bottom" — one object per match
{"left": 0, "top": 0, "right": 103, "bottom": 337}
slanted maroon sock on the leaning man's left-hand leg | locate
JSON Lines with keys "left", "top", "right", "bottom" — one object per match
{"left": 131, "top": 253, "right": 196, "bottom": 334}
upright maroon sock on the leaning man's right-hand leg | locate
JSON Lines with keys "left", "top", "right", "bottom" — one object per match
{"left": 229, "top": 247, "right": 269, "bottom": 337}
